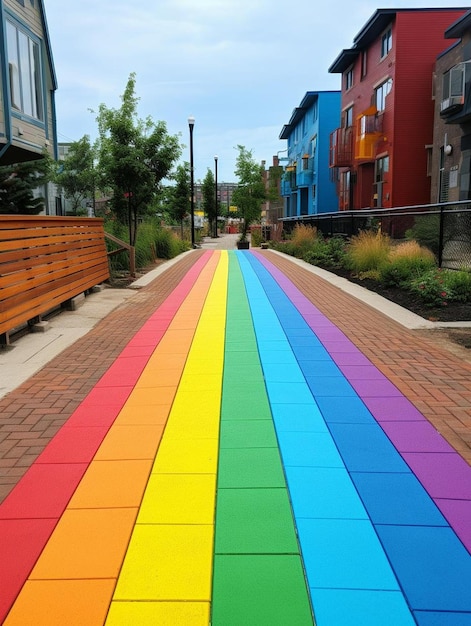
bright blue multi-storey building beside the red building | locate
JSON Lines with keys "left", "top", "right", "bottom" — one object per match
{"left": 280, "top": 91, "right": 340, "bottom": 217}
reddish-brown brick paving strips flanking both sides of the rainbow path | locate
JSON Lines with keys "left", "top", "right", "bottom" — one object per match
{"left": 0, "top": 250, "right": 471, "bottom": 501}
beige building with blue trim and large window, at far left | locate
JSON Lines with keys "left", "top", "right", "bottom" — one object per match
{"left": 0, "top": 0, "right": 57, "bottom": 165}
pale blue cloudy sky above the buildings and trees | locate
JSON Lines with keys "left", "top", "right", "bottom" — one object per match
{"left": 44, "top": 0, "right": 471, "bottom": 181}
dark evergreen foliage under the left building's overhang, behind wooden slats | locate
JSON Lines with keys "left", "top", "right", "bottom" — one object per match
{"left": 0, "top": 154, "right": 52, "bottom": 215}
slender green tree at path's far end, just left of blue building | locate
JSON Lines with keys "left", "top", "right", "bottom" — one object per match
{"left": 232, "top": 145, "right": 266, "bottom": 241}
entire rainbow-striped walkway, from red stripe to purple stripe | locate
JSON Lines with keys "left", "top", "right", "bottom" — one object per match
{"left": 0, "top": 251, "right": 471, "bottom": 626}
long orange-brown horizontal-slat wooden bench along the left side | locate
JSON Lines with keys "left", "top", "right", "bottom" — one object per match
{"left": 0, "top": 215, "right": 110, "bottom": 344}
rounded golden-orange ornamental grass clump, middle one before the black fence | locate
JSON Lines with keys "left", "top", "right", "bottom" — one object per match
{"left": 346, "top": 230, "right": 391, "bottom": 274}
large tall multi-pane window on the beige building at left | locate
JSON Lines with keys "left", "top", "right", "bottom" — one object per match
{"left": 7, "top": 21, "right": 44, "bottom": 120}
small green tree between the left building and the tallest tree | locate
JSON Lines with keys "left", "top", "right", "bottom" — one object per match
{"left": 54, "top": 135, "right": 97, "bottom": 214}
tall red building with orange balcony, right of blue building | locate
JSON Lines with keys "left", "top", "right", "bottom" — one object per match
{"left": 329, "top": 8, "right": 466, "bottom": 210}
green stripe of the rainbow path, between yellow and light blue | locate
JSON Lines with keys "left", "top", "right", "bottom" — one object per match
{"left": 211, "top": 252, "right": 313, "bottom": 626}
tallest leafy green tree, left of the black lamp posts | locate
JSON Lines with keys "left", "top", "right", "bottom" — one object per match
{"left": 97, "top": 73, "right": 181, "bottom": 245}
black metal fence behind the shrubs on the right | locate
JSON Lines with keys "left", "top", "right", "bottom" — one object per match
{"left": 280, "top": 200, "right": 471, "bottom": 269}
